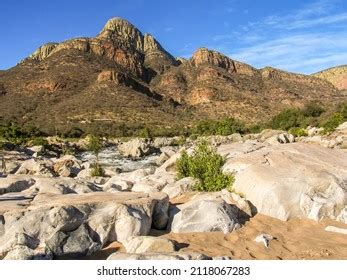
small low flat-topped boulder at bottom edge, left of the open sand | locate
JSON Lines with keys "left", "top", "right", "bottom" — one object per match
{"left": 123, "top": 236, "right": 175, "bottom": 254}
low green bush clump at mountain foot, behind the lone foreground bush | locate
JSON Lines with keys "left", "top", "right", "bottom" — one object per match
{"left": 193, "top": 118, "right": 246, "bottom": 136}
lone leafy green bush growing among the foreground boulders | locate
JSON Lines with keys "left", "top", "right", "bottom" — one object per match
{"left": 176, "top": 143, "right": 234, "bottom": 192}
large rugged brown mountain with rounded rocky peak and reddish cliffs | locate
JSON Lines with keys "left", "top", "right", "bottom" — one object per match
{"left": 0, "top": 18, "right": 345, "bottom": 136}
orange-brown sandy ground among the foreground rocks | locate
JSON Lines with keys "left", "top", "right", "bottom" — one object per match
{"left": 92, "top": 214, "right": 347, "bottom": 260}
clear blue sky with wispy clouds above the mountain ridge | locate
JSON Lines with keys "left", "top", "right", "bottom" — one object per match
{"left": 0, "top": 0, "right": 347, "bottom": 73}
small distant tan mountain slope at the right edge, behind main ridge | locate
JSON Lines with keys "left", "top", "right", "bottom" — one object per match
{"left": 313, "top": 65, "right": 347, "bottom": 90}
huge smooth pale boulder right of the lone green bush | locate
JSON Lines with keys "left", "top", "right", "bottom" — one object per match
{"left": 221, "top": 143, "right": 347, "bottom": 221}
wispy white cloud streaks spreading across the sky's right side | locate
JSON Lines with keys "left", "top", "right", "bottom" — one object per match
{"left": 213, "top": 0, "right": 347, "bottom": 73}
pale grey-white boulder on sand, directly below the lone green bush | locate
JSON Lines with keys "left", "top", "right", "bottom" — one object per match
{"left": 171, "top": 199, "right": 240, "bottom": 234}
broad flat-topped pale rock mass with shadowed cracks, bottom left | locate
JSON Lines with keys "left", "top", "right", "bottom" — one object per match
{"left": 0, "top": 192, "right": 168, "bottom": 259}
